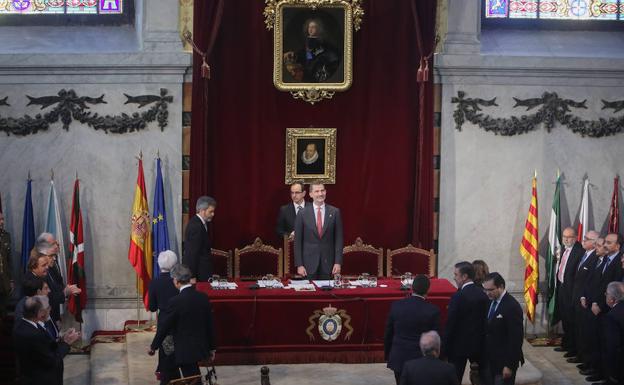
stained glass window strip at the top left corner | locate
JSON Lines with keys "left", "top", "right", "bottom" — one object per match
{"left": 0, "top": 0, "right": 123, "bottom": 15}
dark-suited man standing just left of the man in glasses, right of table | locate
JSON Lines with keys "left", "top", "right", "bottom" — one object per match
{"left": 443, "top": 262, "right": 489, "bottom": 382}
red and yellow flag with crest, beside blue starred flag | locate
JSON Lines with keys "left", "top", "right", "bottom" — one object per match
{"left": 128, "top": 159, "right": 153, "bottom": 309}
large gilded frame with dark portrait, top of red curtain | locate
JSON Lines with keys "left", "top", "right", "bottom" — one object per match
{"left": 264, "top": 0, "right": 364, "bottom": 104}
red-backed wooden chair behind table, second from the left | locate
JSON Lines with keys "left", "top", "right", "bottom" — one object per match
{"left": 234, "top": 238, "right": 283, "bottom": 279}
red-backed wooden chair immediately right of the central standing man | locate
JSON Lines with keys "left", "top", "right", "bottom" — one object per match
{"left": 341, "top": 237, "right": 383, "bottom": 277}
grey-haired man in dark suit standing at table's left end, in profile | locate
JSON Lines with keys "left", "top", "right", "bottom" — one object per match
{"left": 182, "top": 196, "right": 217, "bottom": 282}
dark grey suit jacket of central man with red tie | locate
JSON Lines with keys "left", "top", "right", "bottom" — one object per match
{"left": 295, "top": 204, "right": 344, "bottom": 275}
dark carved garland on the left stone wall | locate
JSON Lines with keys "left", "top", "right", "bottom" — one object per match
{"left": 0, "top": 88, "right": 173, "bottom": 136}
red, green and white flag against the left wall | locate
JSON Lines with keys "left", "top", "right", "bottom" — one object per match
{"left": 67, "top": 178, "right": 87, "bottom": 323}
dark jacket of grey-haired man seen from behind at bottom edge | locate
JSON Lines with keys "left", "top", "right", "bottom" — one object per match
{"left": 399, "top": 357, "right": 459, "bottom": 385}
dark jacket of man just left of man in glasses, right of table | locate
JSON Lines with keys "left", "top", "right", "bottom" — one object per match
{"left": 442, "top": 283, "right": 490, "bottom": 358}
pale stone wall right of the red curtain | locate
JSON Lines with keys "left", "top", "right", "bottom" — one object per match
{"left": 435, "top": 0, "right": 624, "bottom": 310}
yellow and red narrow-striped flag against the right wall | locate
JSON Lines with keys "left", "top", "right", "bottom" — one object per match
{"left": 520, "top": 176, "right": 539, "bottom": 322}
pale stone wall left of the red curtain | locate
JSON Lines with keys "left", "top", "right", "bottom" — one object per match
{"left": 0, "top": 0, "right": 190, "bottom": 337}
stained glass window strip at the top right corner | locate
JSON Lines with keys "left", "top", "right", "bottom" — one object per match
{"left": 484, "top": 0, "right": 624, "bottom": 20}
